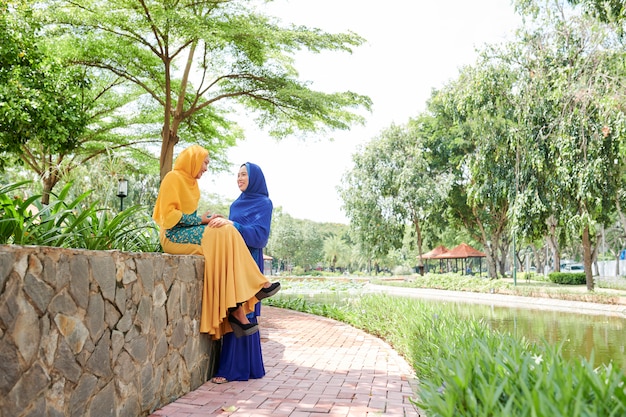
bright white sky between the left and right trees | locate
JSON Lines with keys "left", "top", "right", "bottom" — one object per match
{"left": 200, "top": 0, "right": 520, "bottom": 224}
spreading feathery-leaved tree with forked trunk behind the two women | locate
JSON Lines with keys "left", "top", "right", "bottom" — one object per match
{"left": 43, "top": 0, "right": 371, "bottom": 177}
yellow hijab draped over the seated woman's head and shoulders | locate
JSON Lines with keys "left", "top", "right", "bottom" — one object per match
{"left": 152, "top": 145, "right": 209, "bottom": 229}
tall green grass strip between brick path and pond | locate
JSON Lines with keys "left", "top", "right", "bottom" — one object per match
{"left": 269, "top": 294, "right": 626, "bottom": 417}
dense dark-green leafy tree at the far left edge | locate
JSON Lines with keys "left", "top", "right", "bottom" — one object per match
{"left": 0, "top": 2, "right": 89, "bottom": 204}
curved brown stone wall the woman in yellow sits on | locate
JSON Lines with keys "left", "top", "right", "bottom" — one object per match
{"left": 0, "top": 245, "right": 217, "bottom": 417}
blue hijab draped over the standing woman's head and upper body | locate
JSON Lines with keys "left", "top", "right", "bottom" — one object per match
{"left": 228, "top": 162, "right": 274, "bottom": 256}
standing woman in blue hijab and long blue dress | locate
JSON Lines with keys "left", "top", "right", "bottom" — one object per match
{"left": 211, "top": 162, "right": 274, "bottom": 384}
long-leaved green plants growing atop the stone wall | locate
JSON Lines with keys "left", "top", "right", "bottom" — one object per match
{"left": 0, "top": 181, "right": 159, "bottom": 252}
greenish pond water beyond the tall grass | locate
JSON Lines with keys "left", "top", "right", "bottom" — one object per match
{"left": 282, "top": 292, "right": 626, "bottom": 372}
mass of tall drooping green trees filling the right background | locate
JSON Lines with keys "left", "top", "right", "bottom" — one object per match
{"left": 342, "top": 0, "right": 626, "bottom": 282}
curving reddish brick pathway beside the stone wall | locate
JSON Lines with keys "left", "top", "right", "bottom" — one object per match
{"left": 151, "top": 306, "right": 424, "bottom": 417}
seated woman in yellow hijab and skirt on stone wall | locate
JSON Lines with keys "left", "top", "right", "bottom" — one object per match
{"left": 152, "top": 145, "right": 280, "bottom": 339}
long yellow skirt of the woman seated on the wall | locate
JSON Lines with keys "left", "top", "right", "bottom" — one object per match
{"left": 161, "top": 225, "right": 268, "bottom": 340}
